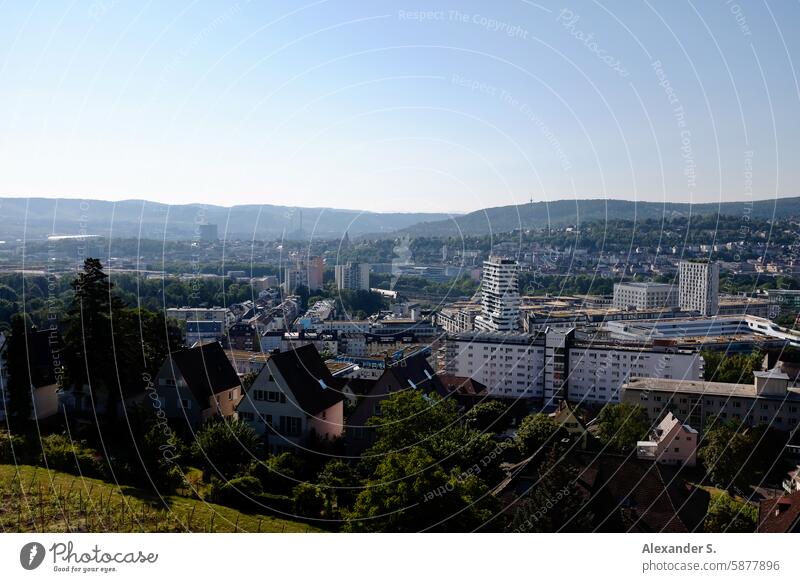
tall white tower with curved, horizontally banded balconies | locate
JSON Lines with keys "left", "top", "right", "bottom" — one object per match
{"left": 475, "top": 257, "right": 519, "bottom": 331}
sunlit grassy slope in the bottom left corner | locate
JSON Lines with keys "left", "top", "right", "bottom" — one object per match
{"left": 0, "top": 465, "right": 317, "bottom": 533}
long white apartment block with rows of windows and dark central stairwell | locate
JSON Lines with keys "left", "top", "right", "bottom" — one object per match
{"left": 444, "top": 330, "right": 703, "bottom": 406}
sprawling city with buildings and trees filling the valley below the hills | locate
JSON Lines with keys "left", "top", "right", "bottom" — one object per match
{"left": 0, "top": 200, "right": 800, "bottom": 532}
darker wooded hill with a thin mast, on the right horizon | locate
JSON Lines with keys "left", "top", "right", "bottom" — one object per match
{"left": 396, "top": 197, "right": 800, "bottom": 236}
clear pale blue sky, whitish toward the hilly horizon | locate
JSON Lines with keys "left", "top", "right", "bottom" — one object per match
{"left": 0, "top": 0, "right": 800, "bottom": 212}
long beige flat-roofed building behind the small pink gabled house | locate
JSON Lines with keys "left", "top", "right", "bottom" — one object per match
{"left": 622, "top": 370, "right": 800, "bottom": 431}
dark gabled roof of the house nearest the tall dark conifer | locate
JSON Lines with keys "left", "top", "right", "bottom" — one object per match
{"left": 172, "top": 342, "right": 239, "bottom": 406}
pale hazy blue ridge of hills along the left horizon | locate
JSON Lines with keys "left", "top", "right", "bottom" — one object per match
{"left": 0, "top": 198, "right": 448, "bottom": 240}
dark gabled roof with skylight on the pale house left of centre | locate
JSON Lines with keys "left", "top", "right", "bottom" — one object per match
{"left": 270, "top": 344, "right": 345, "bottom": 416}
